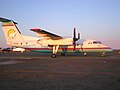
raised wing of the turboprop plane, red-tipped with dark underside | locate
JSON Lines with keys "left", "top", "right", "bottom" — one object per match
{"left": 30, "top": 28, "right": 62, "bottom": 40}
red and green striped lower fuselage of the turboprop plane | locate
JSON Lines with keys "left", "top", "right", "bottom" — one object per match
{"left": 26, "top": 46, "right": 111, "bottom": 53}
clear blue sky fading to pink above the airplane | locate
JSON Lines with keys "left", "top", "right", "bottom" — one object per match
{"left": 0, "top": 0, "right": 120, "bottom": 49}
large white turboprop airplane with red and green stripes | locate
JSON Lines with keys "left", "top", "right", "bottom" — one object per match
{"left": 0, "top": 18, "right": 112, "bottom": 58}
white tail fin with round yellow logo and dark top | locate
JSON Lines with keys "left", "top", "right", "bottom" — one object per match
{"left": 0, "top": 17, "right": 24, "bottom": 46}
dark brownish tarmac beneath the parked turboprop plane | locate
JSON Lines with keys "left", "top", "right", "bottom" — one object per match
{"left": 0, "top": 52, "right": 120, "bottom": 90}
